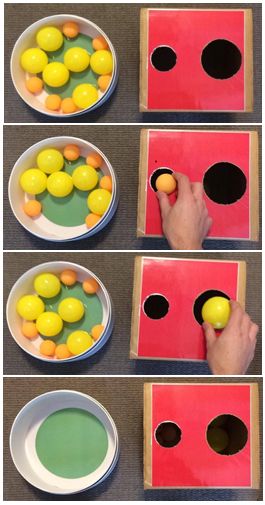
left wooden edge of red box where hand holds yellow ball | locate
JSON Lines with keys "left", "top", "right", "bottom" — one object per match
{"left": 130, "top": 256, "right": 142, "bottom": 359}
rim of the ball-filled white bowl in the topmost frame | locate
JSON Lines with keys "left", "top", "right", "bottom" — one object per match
{"left": 9, "top": 14, "right": 117, "bottom": 119}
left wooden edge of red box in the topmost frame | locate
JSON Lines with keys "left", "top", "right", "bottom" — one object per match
{"left": 139, "top": 9, "right": 148, "bottom": 112}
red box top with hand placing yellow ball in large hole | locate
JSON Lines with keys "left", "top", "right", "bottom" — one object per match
{"left": 137, "top": 257, "right": 238, "bottom": 360}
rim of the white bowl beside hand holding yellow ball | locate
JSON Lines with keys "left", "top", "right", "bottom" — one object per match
{"left": 5, "top": 261, "right": 113, "bottom": 365}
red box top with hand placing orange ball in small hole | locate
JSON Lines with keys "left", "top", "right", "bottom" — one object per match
{"left": 145, "top": 130, "right": 250, "bottom": 239}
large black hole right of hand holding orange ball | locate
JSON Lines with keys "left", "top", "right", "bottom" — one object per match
{"left": 203, "top": 161, "right": 247, "bottom": 205}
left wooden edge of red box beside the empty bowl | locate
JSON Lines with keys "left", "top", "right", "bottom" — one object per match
{"left": 144, "top": 383, "right": 153, "bottom": 489}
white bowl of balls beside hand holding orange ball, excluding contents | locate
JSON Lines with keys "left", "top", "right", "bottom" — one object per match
{"left": 8, "top": 136, "right": 118, "bottom": 242}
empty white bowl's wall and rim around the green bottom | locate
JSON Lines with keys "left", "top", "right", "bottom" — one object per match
{"left": 10, "top": 390, "right": 118, "bottom": 495}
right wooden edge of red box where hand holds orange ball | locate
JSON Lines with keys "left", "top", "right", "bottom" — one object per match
{"left": 250, "top": 131, "right": 259, "bottom": 241}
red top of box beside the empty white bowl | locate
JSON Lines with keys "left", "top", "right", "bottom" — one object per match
{"left": 151, "top": 384, "right": 251, "bottom": 487}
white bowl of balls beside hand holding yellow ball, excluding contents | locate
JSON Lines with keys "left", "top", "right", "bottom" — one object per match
{"left": 6, "top": 261, "right": 113, "bottom": 364}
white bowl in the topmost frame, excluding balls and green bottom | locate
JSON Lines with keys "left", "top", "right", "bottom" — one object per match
{"left": 10, "top": 14, "right": 118, "bottom": 118}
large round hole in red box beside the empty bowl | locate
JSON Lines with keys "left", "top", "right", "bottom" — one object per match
{"left": 206, "top": 414, "right": 248, "bottom": 456}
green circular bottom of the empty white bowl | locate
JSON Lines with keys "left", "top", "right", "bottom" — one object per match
{"left": 35, "top": 408, "right": 108, "bottom": 479}
